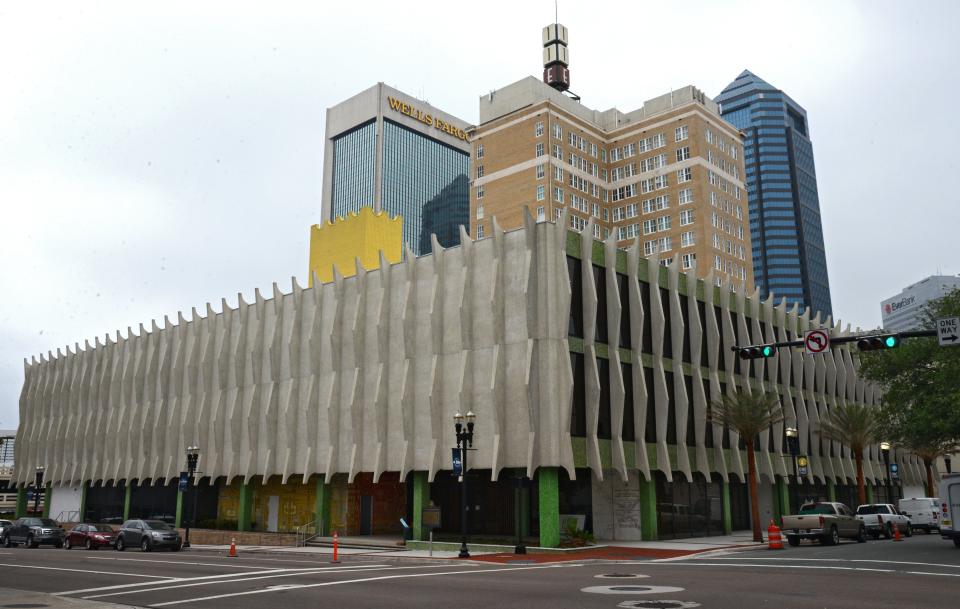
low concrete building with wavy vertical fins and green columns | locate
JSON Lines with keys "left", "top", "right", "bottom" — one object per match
{"left": 16, "top": 215, "right": 922, "bottom": 546}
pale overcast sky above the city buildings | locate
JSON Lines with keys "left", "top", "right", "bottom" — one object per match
{"left": 0, "top": 0, "right": 960, "bottom": 429}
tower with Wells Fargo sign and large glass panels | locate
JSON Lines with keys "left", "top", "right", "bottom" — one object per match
{"left": 322, "top": 83, "right": 470, "bottom": 255}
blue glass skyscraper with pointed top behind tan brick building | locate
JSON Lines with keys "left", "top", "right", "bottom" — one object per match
{"left": 715, "top": 70, "right": 833, "bottom": 317}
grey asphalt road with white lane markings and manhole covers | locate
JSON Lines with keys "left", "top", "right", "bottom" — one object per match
{"left": 0, "top": 535, "right": 960, "bottom": 609}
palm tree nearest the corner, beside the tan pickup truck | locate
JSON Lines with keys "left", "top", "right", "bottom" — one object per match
{"left": 709, "top": 393, "right": 783, "bottom": 542}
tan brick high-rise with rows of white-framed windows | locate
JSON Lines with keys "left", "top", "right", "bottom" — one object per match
{"left": 470, "top": 77, "right": 754, "bottom": 290}
